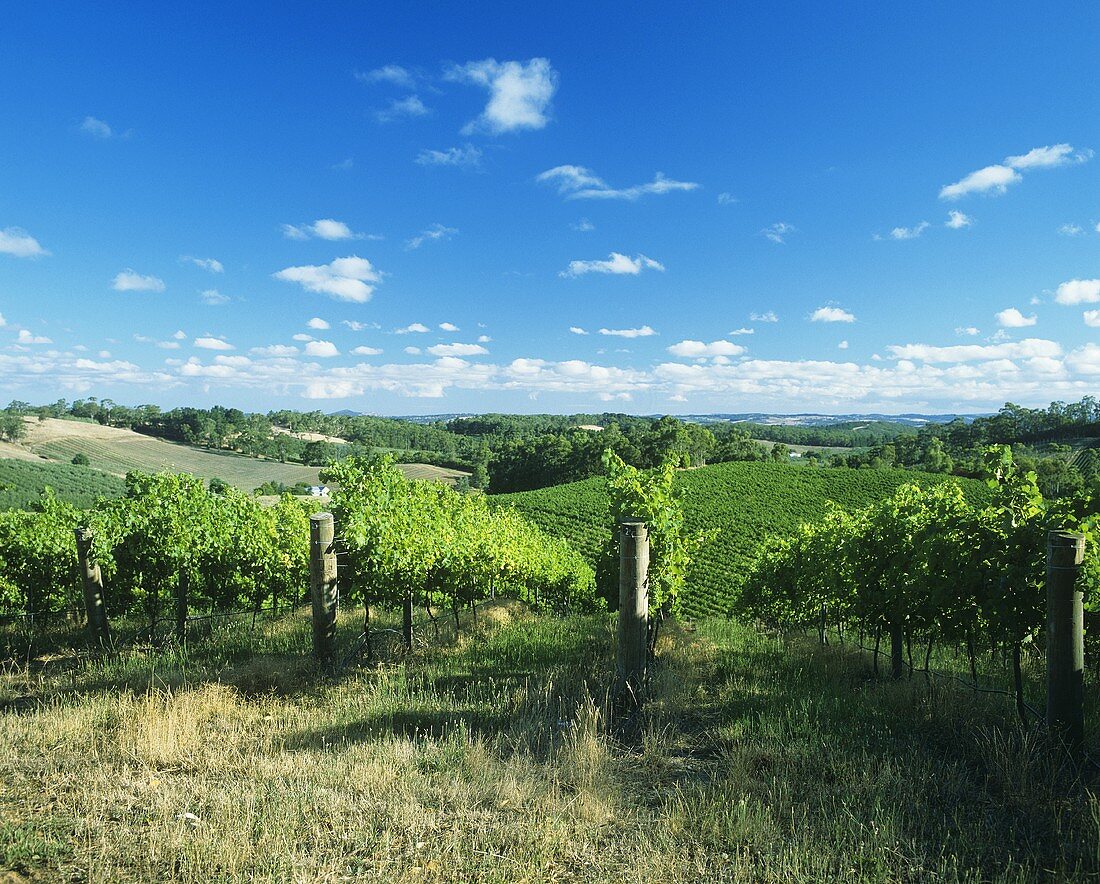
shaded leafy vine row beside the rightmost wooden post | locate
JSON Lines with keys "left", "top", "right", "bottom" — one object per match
{"left": 738, "top": 449, "right": 1100, "bottom": 650}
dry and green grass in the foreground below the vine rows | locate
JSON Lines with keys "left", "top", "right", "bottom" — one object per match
{"left": 0, "top": 605, "right": 1100, "bottom": 882}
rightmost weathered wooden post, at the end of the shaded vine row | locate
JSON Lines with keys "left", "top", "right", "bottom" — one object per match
{"left": 1046, "top": 531, "right": 1085, "bottom": 745}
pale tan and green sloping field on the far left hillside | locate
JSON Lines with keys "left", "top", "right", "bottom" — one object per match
{"left": 0, "top": 418, "right": 469, "bottom": 491}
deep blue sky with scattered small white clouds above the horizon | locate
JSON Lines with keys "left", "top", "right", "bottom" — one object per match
{"left": 0, "top": 2, "right": 1100, "bottom": 413}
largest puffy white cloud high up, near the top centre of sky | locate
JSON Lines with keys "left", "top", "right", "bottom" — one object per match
{"left": 444, "top": 58, "right": 558, "bottom": 134}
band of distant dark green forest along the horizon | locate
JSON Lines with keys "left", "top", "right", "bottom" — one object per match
{"left": 0, "top": 396, "right": 1100, "bottom": 497}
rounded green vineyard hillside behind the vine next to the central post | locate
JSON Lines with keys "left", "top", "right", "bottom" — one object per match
{"left": 491, "top": 463, "right": 986, "bottom": 617}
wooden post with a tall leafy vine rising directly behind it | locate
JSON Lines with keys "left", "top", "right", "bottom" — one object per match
{"left": 616, "top": 519, "right": 649, "bottom": 706}
